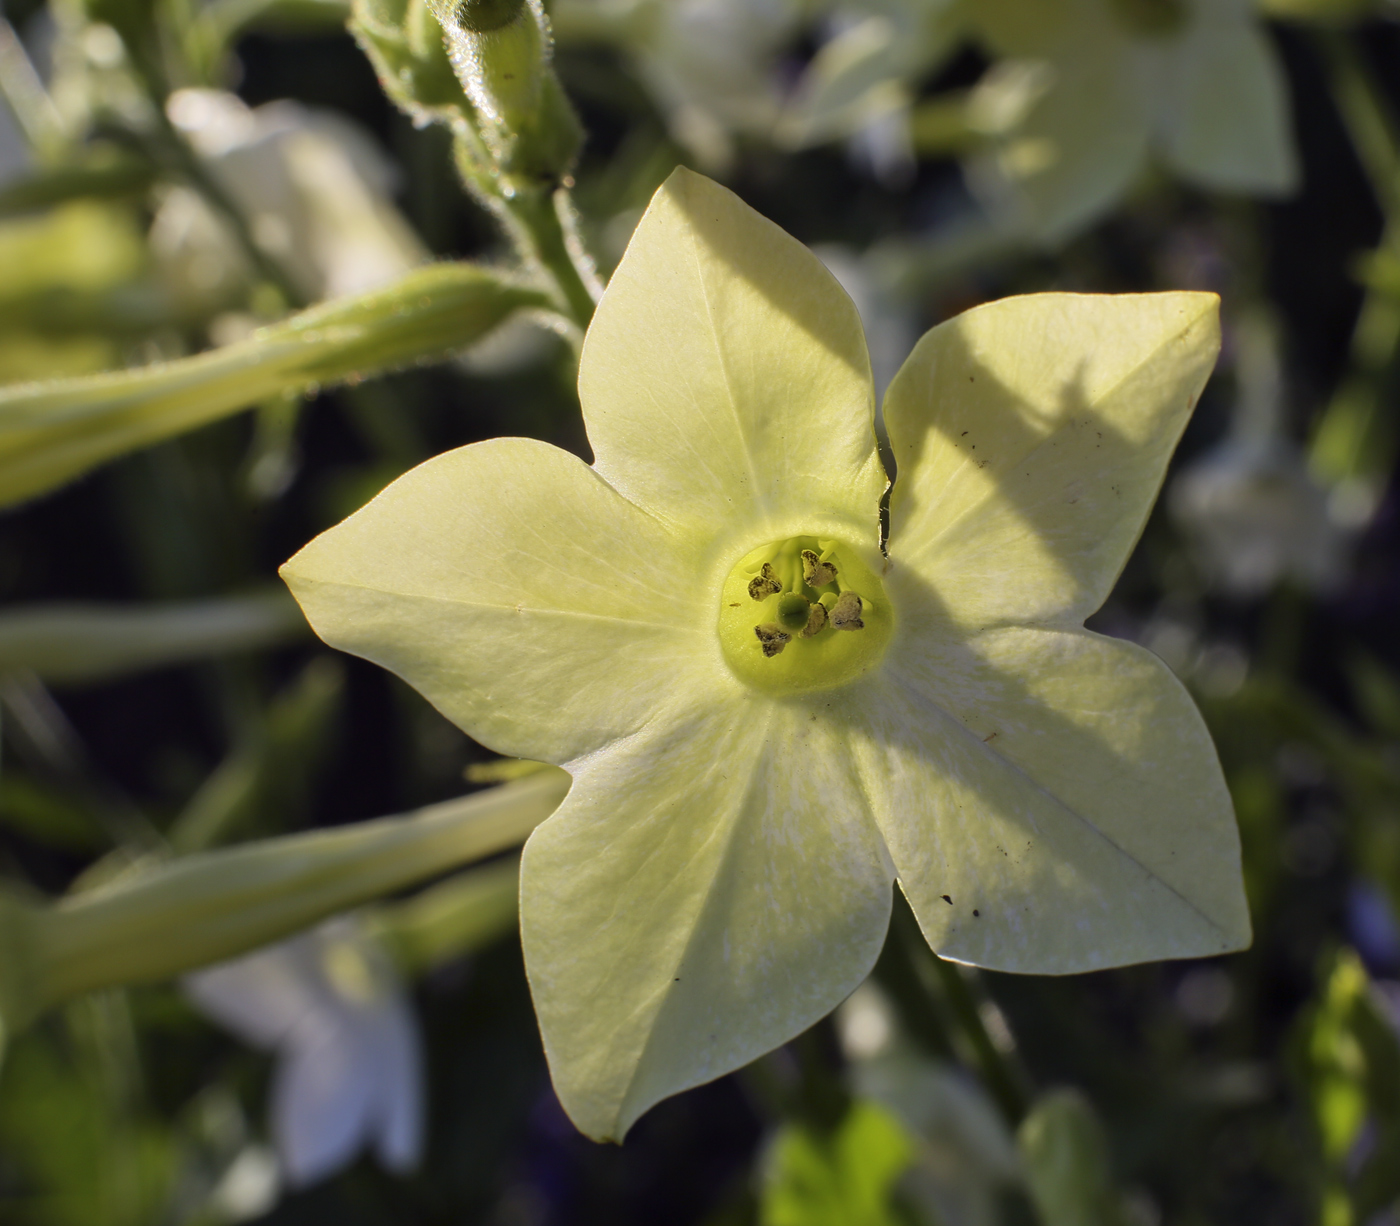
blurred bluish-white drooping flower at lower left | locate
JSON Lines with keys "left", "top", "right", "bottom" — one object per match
{"left": 183, "top": 917, "right": 423, "bottom": 1187}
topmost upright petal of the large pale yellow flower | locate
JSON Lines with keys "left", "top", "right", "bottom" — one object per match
{"left": 578, "top": 168, "right": 885, "bottom": 540}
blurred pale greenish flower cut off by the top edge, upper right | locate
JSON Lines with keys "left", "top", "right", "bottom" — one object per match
{"left": 965, "top": 0, "right": 1298, "bottom": 245}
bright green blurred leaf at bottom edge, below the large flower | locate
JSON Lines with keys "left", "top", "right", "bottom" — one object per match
{"left": 759, "top": 1100, "right": 914, "bottom": 1226}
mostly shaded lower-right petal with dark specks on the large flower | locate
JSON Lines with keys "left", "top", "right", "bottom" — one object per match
{"left": 854, "top": 626, "right": 1250, "bottom": 974}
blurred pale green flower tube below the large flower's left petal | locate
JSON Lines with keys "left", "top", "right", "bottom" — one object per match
{"left": 25, "top": 770, "right": 568, "bottom": 1024}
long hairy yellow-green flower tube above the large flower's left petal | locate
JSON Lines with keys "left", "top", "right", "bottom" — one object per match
{"left": 0, "top": 263, "right": 549, "bottom": 507}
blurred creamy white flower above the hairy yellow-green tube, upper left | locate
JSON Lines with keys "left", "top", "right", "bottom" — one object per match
{"left": 151, "top": 90, "right": 428, "bottom": 309}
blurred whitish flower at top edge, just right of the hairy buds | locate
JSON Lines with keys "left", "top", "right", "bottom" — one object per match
{"left": 552, "top": 0, "right": 804, "bottom": 172}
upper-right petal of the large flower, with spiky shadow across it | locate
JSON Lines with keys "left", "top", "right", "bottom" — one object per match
{"left": 885, "top": 293, "right": 1219, "bottom": 627}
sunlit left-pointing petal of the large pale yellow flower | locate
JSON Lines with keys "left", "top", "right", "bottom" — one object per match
{"left": 281, "top": 438, "right": 732, "bottom": 763}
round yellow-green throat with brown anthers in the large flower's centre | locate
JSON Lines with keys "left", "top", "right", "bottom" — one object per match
{"left": 720, "top": 536, "right": 893, "bottom": 694}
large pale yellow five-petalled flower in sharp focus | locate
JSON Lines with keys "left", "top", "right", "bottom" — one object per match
{"left": 283, "top": 169, "right": 1249, "bottom": 1138}
